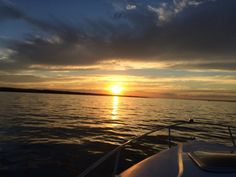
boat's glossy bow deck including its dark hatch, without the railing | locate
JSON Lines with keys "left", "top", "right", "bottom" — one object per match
{"left": 118, "top": 141, "right": 236, "bottom": 177}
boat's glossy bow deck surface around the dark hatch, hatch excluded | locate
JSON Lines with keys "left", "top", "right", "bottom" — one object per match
{"left": 118, "top": 141, "right": 236, "bottom": 177}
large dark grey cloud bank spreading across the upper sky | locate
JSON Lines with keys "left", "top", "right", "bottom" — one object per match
{"left": 0, "top": 0, "right": 236, "bottom": 70}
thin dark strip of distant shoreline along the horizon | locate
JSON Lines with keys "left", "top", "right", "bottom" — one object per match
{"left": 0, "top": 87, "right": 236, "bottom": 103}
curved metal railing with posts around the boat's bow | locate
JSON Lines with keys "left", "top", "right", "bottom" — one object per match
{"left": 78, "top": 119, "right": 236, "bottom": 177}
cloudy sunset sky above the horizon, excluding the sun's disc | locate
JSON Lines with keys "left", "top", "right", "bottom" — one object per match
{"left": 0, "top": 0, "right": 236, "bottom": 100}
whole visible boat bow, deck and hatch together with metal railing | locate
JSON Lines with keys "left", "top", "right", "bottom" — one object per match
{"left": 78, "top": 119, "right": 236, "bottom": 177}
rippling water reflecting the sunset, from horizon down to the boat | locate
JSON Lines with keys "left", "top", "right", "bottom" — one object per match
{"left": 0, "top": 93, "right": 236, "bottom": 177}
